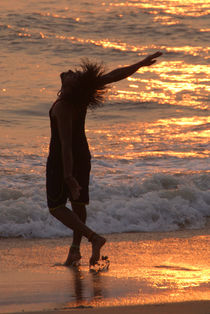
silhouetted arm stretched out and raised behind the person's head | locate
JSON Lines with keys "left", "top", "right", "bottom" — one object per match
{"left": 101, "top": 51, "right": 162, "bottom": 85}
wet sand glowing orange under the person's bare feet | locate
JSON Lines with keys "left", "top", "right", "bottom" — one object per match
{"left": 0, "top": 222, "right": 210, "bottom": 314}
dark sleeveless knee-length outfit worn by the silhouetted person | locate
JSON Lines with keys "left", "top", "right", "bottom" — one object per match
{"left": 46, "top": 102, "right": 91, "bottom": 209}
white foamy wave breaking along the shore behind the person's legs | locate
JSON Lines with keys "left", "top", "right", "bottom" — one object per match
{"left": 0, "top": 162, "right": 210, "bottom": 238}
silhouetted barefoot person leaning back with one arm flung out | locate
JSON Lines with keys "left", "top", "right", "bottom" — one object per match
{"left": 47, "top": 52, "right": 161, "bottom": 265}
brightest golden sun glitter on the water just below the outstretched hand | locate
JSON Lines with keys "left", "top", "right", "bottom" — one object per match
{"left": 113, "top": 61, "right": 210, "bottom": 109}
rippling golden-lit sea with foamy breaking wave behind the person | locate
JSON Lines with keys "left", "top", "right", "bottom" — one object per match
{"left": 0, "top": 0, "right": 210, "bottom": 238}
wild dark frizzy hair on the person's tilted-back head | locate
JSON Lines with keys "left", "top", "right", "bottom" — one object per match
{"left": 58, "top": 59, "right": 107, "bottom": 109}
